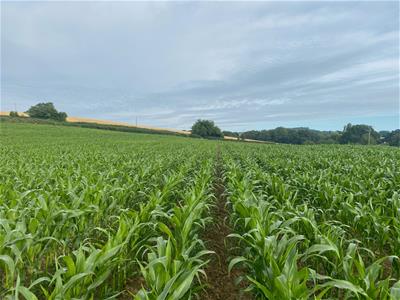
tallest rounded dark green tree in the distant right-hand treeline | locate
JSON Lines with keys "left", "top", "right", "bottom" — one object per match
{"left": 340, "top": 123, "right": 379, "bottom": 145}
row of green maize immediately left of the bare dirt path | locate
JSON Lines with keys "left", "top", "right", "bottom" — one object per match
{"left": 135, "top": 161, "right": 216, "bottom": 299}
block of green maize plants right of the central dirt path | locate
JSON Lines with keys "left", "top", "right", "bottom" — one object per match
{"left": 224, "top": 145, "right": 400, "bottom": 299}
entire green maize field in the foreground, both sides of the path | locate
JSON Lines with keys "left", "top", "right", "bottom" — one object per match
{"left": 0, "top": 122, "right": 400, "bottom": 299}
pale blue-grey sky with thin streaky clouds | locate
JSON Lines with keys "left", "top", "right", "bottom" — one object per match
{"left": 1, "top": 1, "right": 400, "bottom": 131}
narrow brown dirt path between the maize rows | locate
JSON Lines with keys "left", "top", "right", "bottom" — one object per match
{"left": 200, "top": 147, "right": 252, "bottom": 300}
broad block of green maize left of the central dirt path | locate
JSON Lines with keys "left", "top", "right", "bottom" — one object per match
{"left": 0, "top": 124, "right": 215, "bottom": 299}
